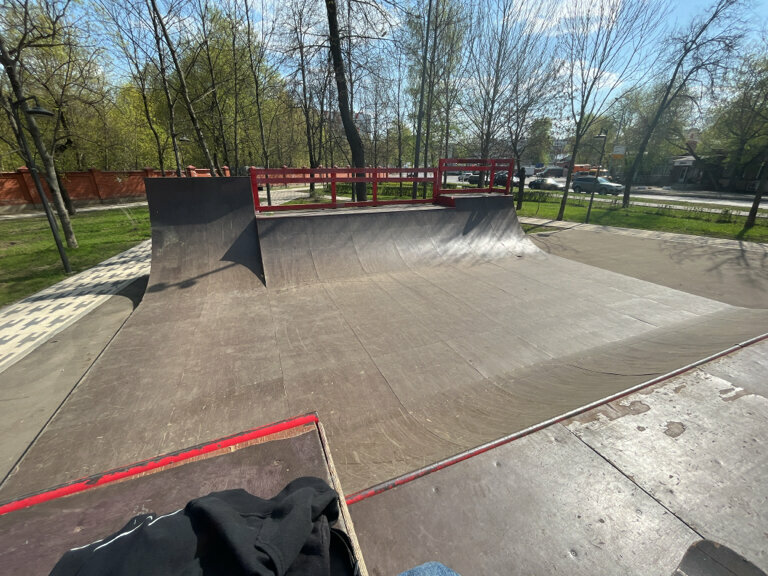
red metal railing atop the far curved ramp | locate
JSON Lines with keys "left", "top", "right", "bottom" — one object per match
{"left": 249, "top": 158, "right": 514, "bottom": 212}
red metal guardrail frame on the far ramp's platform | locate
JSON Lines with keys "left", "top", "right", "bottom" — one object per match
{"left": 248, "top": 158, "right": 515, "bottom": 212}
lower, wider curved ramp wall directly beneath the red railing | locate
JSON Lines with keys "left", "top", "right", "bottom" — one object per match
{"left": 256, "top": 195, "right": 539, "bottom": 289}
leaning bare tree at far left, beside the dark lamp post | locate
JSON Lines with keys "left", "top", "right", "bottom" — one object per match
{"left": 0, "top": 0, "right": 77, "bottom": 248}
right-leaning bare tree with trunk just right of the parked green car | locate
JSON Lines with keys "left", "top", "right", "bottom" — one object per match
{"left": 623, "top": 0, "right": 744, "bottom": 208}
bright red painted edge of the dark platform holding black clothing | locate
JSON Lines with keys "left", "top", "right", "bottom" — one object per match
{"left": 0, "top": 413, "right": 318, "bottom": 516}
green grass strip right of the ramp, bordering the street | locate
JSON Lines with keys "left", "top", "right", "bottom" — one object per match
{"left": 520, "top": 194, "right": 768, "bottom": 242}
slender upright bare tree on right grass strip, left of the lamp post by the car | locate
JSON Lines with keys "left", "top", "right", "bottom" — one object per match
{"left": 557, "top": 0, "right": 667, "bottom": 220}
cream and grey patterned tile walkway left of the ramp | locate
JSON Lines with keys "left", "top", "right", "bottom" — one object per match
{"left": 0, "top": 240, "right": 152, "bottom": 372}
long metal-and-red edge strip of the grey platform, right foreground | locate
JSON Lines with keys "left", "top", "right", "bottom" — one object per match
{"left": 344, "top": 334, "right": 768, "bottom": 506}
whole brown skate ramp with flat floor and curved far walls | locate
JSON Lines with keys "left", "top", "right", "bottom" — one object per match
{"left": 0, "top": 178, "right": 768, "bottom": 500}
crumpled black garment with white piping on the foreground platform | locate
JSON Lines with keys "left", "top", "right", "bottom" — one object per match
{"left": 51, "top": 478, "right": 354, "bottom": 576}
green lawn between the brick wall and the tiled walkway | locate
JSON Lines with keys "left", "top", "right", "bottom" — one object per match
{"left": 0, "top": 206, "right": 150, "bottom": 306}
